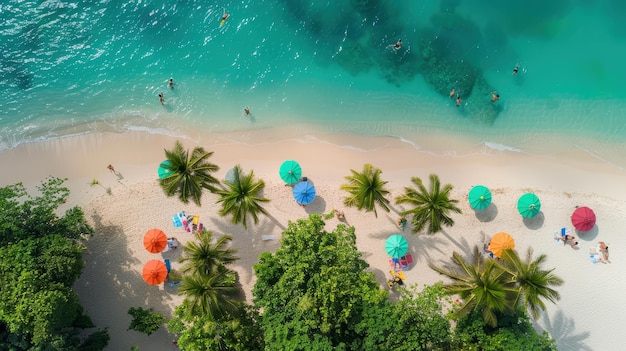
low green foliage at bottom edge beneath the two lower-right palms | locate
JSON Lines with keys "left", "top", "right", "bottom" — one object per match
{"left": 455, "top": 308, "right": 556, "bottom": 351}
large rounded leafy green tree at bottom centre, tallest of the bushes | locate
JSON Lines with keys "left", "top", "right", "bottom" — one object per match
{"left": 253, "top": 215, "right": 387, "bottom": 350}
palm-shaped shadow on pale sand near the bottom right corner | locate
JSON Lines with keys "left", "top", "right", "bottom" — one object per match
{"left": 533, "top": 309, "right": 592, "bottom": 351}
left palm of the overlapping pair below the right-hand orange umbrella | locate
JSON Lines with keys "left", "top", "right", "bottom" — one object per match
{"left": 428, "top": 246, "right": 517, "bottom": 327}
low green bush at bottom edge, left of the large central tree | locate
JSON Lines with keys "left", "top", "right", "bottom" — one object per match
{"left": 168, "top": 303, "right": 265, "bottom": 351}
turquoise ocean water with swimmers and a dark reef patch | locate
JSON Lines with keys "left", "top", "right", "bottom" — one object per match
{"left": 0, "top": 0, "right": 626, "bottom": 167}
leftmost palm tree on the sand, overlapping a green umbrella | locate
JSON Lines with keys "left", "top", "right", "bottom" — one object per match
{"left": 159, "top": 141, "right": 219, "bottom": 206}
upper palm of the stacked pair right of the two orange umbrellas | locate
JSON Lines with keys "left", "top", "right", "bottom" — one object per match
{"left": 180, "top": 230, "right": 237, "bottom": 275}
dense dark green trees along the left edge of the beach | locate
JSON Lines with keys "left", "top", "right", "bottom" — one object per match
{"left": 0, "top": 178, "right": 109, "bottom": 351}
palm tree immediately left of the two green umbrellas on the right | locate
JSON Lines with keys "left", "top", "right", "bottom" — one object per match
{"left": 396, "top": 174, "right": 461, "bottom": 234}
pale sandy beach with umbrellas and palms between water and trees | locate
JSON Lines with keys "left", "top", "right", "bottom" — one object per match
{"left": 0, "top": 131, "right": 626, "bottom": 350}
